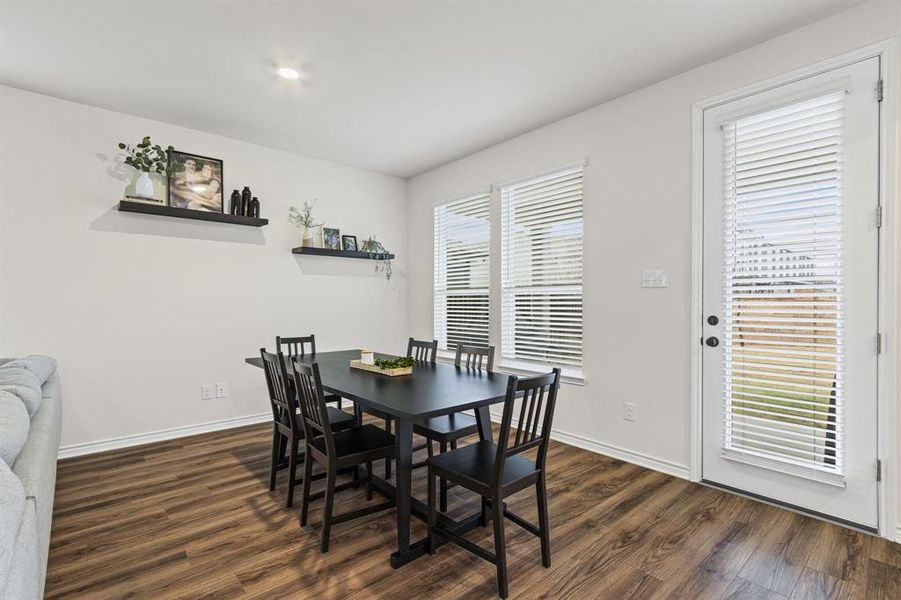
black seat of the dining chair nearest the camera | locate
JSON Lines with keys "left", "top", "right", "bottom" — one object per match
{"left": 428, "top": 440, "right": 537, "bottom": 487}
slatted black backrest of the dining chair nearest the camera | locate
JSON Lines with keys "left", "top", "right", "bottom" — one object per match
{"left": 494, "top": 369, "right": 560, "bottom": 485}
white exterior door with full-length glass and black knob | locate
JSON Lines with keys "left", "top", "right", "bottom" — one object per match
{"left": 702, "top": 58, "right": 880, "bottom": 528}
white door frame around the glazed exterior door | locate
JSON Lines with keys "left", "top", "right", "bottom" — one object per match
{"left": 689, "top": 39, "right": 901, "bottom": 542}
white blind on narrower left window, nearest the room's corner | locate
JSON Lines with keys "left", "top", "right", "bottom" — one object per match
{"left": 433, "top": 191, "right": 491, "bottom": 350}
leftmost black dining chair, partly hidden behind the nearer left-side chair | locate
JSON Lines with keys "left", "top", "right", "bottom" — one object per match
{"left": 260, "top": 348, "right": 354, "bottom": 508}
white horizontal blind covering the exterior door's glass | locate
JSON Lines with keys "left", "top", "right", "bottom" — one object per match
{"left": 723, "top": 92, "right": 844, "bottom": 474}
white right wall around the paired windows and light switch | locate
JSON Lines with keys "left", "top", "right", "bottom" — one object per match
{"left": 408, "top": 2, "right": 901, "bottom": 516}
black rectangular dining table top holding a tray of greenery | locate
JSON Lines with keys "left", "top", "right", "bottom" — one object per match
{"left": 245, "top": 350, "right": 509, "bottom": 420}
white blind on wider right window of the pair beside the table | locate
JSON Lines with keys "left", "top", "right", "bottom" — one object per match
{"left": 501, "top": 165, "right": 583, "bottom": 367}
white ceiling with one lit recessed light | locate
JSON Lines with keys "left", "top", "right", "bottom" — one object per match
{"left": 0, "top": 0, "right": 858, "bottom": 177}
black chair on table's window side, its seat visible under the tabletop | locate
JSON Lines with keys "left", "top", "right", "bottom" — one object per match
{"left": 413, "top": 344, "right": 494, "bottom": 512}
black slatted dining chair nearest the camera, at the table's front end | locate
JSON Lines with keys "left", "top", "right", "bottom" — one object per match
{"left": 428, "top": 369, "right": 560, "bottom": 598}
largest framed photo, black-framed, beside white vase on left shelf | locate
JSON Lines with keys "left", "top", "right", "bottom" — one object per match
{"left": 169, "top": 150, "right": 223, "bottom": 213}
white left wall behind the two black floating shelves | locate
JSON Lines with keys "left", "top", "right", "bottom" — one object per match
{"left": 0, "top": 87, "right": 407, "bottom": 446}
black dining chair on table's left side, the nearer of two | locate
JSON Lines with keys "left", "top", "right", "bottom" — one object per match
{"left": 292, "top": 361, "right": 394, "bottom": 552}
